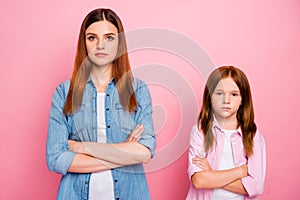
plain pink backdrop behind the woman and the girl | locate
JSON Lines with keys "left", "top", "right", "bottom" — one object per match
{"left": 0, "top": 0, "right": 300, "bottom": 200}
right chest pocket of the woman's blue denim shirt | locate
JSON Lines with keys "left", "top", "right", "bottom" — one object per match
{"left": 113, "top": 103, "right": 136, "bottom": 134}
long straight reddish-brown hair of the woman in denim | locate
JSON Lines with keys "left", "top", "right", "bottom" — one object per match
{"left": 63, "top": 9, "right": 138, "bottom": 115}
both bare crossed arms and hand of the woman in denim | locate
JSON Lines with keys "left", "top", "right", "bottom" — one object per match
{"left": 68, "top": 125, "right": 151, "bottom": 173}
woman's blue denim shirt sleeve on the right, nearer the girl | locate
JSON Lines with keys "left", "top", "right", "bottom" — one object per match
{"left": 136, "top": 81, "right": 156, "bottom": 157}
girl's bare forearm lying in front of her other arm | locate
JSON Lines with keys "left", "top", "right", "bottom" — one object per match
{"left": 192, "top": 167, "right": 247, "bottom": 189}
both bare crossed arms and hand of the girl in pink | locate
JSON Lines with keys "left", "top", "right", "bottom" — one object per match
{"left": 191, "top": 156, "right": 248, "bottom": 195}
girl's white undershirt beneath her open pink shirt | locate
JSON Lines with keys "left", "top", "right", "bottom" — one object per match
{"left": 211, "top": 129, "right": 244, "bottom": 200}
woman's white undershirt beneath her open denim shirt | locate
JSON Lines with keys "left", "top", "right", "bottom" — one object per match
{"left": 89, "top": 93, "right": 114, "bottom": 200}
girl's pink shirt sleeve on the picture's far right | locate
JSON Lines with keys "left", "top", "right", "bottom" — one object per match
{"left": 242, "top": 131, "right": 266, "bottom": 198}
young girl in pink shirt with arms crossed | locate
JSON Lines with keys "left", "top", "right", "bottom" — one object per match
{"left": 186, "top": 66, "right": 266, "bottom": 200}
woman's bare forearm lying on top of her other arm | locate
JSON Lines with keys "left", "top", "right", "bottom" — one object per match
{"left": 80, "top": 142, "right": 151, "bottom": 165}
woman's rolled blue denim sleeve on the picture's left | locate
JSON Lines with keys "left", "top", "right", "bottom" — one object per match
{"left": 46, "top": 83, "right": 75, "bottom": 174}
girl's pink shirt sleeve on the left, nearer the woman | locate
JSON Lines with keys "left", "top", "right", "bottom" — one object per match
{"left": 188, "top": 125, "right": 204, "bottom": 181}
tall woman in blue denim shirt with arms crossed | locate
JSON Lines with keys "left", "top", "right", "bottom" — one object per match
{"left": 47, "top": 9, "right": 156, "bottom": 200}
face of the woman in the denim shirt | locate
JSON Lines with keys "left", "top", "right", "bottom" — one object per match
{"left": 85, "top": 20, "right": 119, "bottom": 67}
